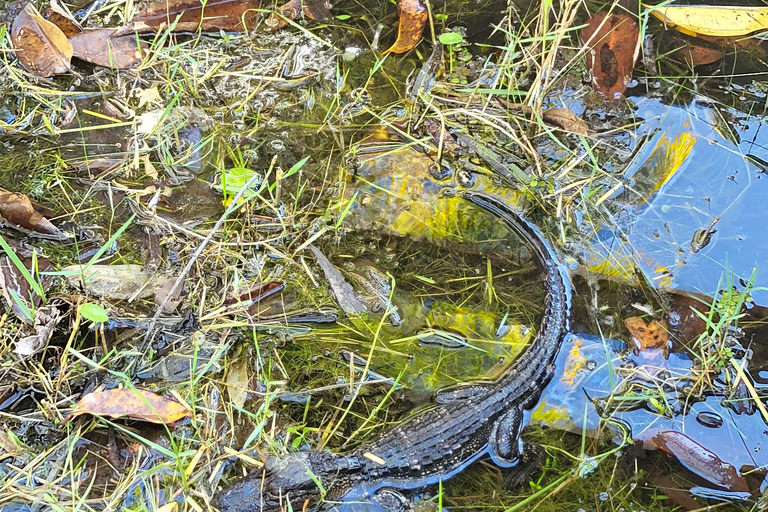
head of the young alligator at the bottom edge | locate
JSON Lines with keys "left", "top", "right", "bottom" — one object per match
{"left": 214, "top": 450, "right": 344, "bottom": 512}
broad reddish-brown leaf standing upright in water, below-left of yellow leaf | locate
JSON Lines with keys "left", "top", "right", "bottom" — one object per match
{"left": 581, "top": 12, "right": 640, "bottom": 98}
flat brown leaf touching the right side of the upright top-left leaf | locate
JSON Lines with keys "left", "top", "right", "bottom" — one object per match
{"left": 69, "top": 28, "right": 148, "bottom": 69}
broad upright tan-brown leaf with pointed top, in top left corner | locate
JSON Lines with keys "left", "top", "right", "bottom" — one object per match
{"left": 11, "top": 4, "right": 72, "bottom": 78}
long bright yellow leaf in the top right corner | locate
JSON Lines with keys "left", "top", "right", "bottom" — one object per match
{"left": 646, "top": 5, "right": 768, "bottom": 37}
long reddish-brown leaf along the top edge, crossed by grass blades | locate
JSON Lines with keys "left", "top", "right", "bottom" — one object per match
{"left": 112, "top": 0, "right": 261, "bottom": 37}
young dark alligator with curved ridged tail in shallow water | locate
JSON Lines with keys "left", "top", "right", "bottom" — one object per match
{"left": 216, "top": 192, "right": 571, "bottom": 512}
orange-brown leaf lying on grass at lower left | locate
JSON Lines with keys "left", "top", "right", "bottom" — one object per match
{"left": 66, "top": 389, "right": 190, "bottom": 423}
